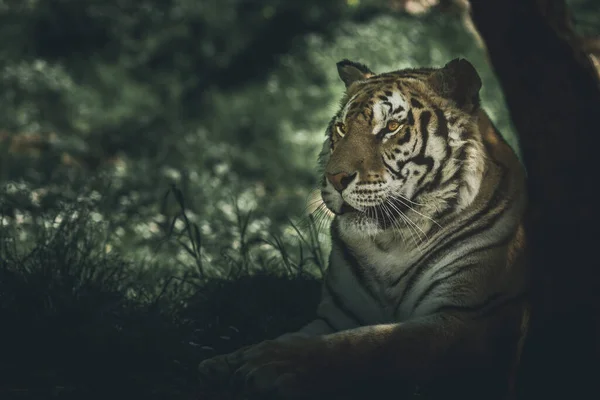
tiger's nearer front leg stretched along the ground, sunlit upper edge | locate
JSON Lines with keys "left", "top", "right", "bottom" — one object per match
{"left": 199, "top": 314, "right": 524, "bottom": 398}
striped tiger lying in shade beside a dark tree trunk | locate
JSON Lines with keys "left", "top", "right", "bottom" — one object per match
{"left": 200, "top": 58, "right": 530, "bottom": 399}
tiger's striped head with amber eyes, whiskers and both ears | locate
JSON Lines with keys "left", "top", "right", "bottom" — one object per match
{"left": 321, "top": 59, "right": 485, "bottom": 234}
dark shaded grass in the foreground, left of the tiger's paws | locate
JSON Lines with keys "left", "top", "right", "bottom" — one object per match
{"left": 0, "top": 207, "right": 320, "bottom": 399}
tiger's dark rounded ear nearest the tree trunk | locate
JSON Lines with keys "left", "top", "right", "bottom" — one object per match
{"left": 429, "top": 58, "right": 481, "bottom": 112}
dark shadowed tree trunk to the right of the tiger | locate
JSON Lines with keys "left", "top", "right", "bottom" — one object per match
{"left": 471, "top": 0, "right": 600, "bottom": 399}
